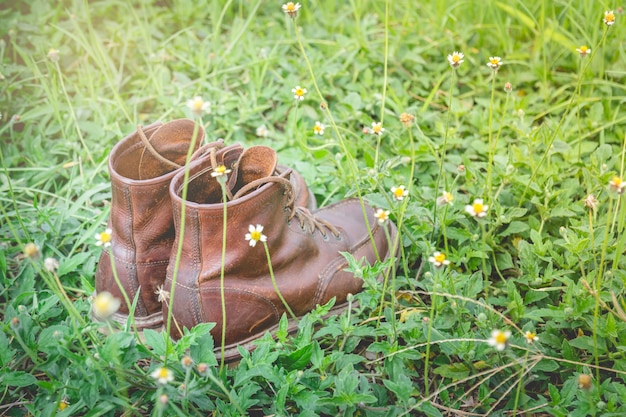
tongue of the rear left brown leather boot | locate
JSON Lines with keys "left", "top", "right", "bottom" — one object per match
{"left": 138, "top": 119, "right": 204, "bottom": 179}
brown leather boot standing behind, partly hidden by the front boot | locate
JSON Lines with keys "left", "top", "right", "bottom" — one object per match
{"left": 92, "top": 119, "right": 315, "bottom": 329}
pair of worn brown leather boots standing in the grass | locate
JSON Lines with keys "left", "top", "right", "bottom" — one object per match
{"left": 96, "top": 119, "right": 396, "bottom": 359}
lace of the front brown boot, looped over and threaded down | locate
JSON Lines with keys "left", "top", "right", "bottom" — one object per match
{"left": 233, "top": 171, "right": 341, "bottom": 239}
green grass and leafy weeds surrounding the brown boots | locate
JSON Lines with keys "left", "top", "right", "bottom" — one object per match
{"left": 0, "top": 0, "right": 626, "bottom": 416}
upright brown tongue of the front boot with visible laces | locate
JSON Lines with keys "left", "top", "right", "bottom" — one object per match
{"left": 227, "top": 146, "right": 278, "bottom": 198}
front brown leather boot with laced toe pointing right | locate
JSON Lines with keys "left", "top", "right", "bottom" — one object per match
{"left": 163, "top": 147, "right": 396, "bottom": 359}
